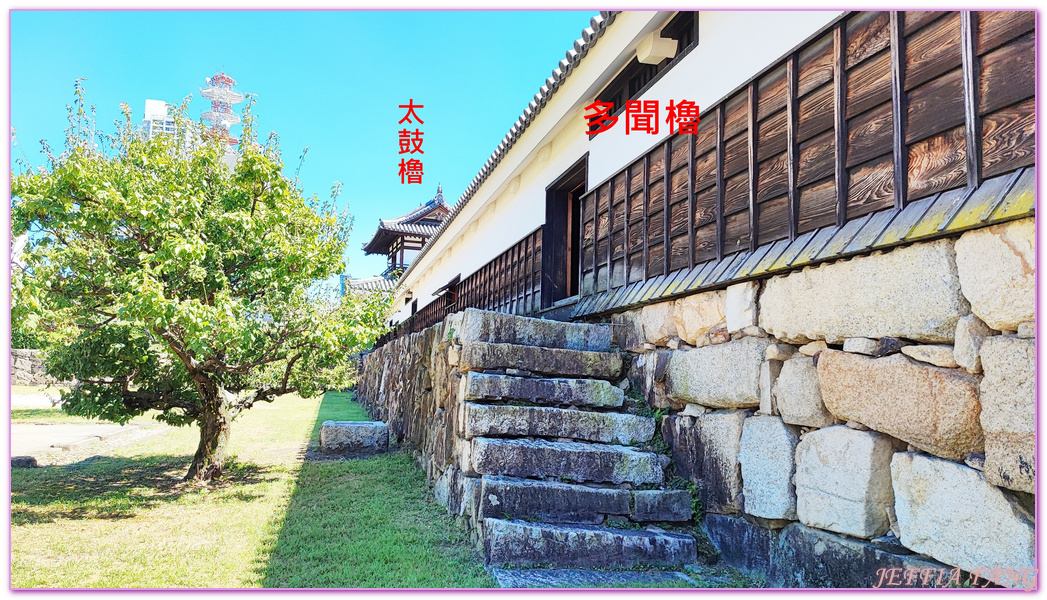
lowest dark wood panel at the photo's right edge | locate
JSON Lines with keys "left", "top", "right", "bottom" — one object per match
{"left": 982, "top": 98, "right": 1037, "bottom": 177}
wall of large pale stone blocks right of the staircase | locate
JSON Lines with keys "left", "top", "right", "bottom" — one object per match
{"left": 612, "top": 219, "right": 1035, "bottom": 586}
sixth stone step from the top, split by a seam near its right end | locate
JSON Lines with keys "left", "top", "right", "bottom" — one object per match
{"left": 480, "top": 475, "right": 691, "bottom": 525}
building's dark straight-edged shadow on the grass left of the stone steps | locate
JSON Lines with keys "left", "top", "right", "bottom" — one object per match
{"left": 255, "top": 393, "right": 493, "bottom": 587}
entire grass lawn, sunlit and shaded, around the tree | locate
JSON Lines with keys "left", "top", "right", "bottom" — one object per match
{"left": 12, "top": 393, "right": 493, "bottom": 587}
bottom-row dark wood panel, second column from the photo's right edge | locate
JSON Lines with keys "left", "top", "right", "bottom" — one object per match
{"left": 909, "top": 127, "right": 967, "bottom": 200}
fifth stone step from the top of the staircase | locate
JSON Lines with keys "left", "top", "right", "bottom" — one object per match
{"left": 469, "top": 438, "right": 665, "bottom": 485}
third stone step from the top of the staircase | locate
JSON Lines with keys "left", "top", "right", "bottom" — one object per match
{"left": 461, "top": 372, "right": 625, "bottom": 408}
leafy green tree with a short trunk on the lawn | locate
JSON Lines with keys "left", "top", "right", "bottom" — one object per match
{"left": 12, "top": 80, "right": 389, "bottom": 481}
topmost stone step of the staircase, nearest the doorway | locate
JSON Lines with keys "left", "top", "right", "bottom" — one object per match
{"left": 454, "top": 308, "right": 611, "bottom": 352}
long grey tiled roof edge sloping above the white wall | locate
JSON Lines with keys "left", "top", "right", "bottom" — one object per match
{"left": 400, "top": 10, "right": 620, "bottom": 281}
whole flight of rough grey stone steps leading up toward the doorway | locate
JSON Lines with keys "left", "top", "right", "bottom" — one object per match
{"left": 456, "top": 311, "right": 696, "bottom": 570}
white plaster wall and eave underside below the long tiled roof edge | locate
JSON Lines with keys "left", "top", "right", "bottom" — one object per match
{"left": 393, "top": 10, "right": 840, "bottom": 321}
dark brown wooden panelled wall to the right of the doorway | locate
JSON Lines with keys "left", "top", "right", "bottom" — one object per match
{"left": 581, "top": 10, "right": 1035, "bottom": 295}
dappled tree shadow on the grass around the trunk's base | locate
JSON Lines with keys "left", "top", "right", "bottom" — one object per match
{"left": 10, "top": 455, "right": 279, "bottom": 526}
